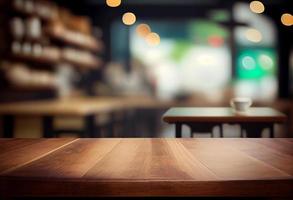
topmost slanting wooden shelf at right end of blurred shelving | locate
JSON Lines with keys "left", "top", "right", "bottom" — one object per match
{"left": 46, "top": 28, "right": 103, "bottom": 53}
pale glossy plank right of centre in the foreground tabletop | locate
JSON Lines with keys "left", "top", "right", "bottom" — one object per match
{"left": 182, "top": 139, "right": 291, "bottom": 180}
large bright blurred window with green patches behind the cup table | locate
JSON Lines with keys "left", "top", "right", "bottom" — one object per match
{"left": 130, "top": 20, "right": 231, "bottom": 99}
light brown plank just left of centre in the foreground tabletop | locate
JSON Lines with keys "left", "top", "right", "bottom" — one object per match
{"left": 84, "top": 139, "right": 152, "bottom": 180}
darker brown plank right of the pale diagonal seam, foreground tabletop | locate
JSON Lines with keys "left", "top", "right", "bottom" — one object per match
{"left": 9, "top": 139, "right": 120, "bottom": 178}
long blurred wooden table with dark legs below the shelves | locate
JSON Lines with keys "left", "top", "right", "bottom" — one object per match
{"left": 0, "top": 98, "right": 123, "bottom": 138}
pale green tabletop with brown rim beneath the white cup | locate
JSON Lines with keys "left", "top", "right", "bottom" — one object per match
{"left": 163, "top": 107, "right": 286, "bottom": 123}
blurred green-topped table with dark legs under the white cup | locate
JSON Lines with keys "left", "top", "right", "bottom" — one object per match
{"left": 163, "top": 107, "right": 286, "bottom": 137}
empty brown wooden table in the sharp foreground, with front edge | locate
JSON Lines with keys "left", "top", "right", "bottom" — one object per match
{"left": 0, "top": 138, "right": 293, "bottom": 197}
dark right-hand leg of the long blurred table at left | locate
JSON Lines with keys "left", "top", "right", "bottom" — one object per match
{"left": 81, "top": 115, "right": 100, "bottom": 138}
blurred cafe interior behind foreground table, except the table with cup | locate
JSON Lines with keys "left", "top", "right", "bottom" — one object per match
{"left": 0, "top": 0, "right": 293, "bottom": 138}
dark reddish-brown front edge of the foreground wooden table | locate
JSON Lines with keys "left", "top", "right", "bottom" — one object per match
{"left": 0, "top": 177, "right": 293, "bottom": 197}
